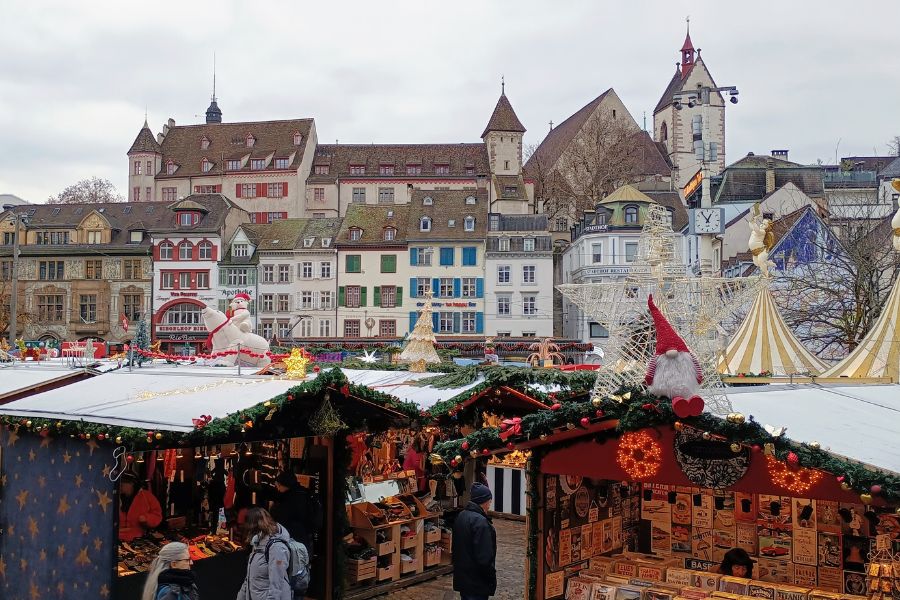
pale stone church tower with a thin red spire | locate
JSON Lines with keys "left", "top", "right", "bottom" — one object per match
{"left": 653, "top": 21, "right": 725, "bottom": 189}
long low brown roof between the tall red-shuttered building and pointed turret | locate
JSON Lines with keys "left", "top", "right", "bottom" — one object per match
{"left": 308, "top": 143, "right": 490, "bottom": 183}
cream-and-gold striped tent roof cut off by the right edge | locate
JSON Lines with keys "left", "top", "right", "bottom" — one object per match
{"left": 823, "top": 277, "right": 900, "bottom": 382}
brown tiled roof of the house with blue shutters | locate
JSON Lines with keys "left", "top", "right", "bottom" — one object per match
{"left": 406, "top": 188, "right": 488, "bottom": 241}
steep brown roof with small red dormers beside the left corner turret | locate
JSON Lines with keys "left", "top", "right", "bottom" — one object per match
{"left": 156, "top": 119, "right": 313, "bottom": 179}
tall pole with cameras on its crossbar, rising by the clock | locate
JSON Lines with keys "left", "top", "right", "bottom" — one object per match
{"left": 672, "top": 85, "right": 740, "bottom": 276}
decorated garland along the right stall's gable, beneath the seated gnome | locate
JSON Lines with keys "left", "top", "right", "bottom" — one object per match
{"left": 434, "top": 388, "right": 900, "bottom": 504}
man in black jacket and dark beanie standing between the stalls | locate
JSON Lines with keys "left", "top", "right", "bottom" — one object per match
{"left": 453, "top": 483, "right": 497, "bottom": 600}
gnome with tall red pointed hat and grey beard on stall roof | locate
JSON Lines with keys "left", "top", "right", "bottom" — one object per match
{"left": 644, "top": 295, "right": 703, "bottom": 419}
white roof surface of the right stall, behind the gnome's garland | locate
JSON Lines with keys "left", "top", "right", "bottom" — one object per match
{"left": 728, "top": 385, "right": 900, "bottom": 473}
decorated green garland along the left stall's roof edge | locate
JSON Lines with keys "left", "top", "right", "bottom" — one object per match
{"left": 0, "top": 368, "right": 422, "bottom": 450}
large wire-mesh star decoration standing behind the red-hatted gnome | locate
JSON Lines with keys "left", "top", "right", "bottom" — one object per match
{"left": 557, "top": 203, "right": 760, "bottom": 415}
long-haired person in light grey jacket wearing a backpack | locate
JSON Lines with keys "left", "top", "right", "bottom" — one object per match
{"left": 237, "top": 506, "right": 294, "bottom": 600}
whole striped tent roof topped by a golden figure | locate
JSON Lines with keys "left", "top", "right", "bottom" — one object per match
{"left": 719, "top": 287, "right": 827, "bottom": 375}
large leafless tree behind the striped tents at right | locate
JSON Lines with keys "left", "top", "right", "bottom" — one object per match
{"left": 774, "top": 205, "right": 900, "bottom": 359}
